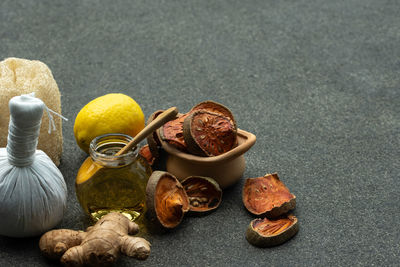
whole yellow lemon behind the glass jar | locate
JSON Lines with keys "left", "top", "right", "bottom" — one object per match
{"left": 74, "top": 94, "right": 144, "bottom": 153}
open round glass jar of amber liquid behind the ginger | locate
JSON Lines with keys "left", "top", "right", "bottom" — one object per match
{"left": 75, "top": 134, "right": 151, "bottom": 221}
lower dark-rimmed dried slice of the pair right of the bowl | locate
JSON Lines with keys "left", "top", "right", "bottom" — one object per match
{"left": 246, "top": 215, "right": 299, "bottom": 247}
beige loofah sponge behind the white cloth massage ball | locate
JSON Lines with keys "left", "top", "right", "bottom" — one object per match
{"left": 0, "top": 58, "right": 63, "bottom": 166}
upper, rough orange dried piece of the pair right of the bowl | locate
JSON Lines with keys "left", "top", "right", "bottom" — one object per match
{"left": 242, "top": 173, "right": 296, "bottom": 218}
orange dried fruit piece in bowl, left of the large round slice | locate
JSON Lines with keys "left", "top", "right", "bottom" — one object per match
{"left": 160, "top": 113, "right": 189, "bottom": 151}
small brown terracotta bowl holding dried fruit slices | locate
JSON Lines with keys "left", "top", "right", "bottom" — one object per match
{"left": 161, "top": 129, "right": 256, "bottom": 188}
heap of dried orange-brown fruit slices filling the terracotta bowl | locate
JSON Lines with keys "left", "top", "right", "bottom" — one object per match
{"left": 141, "top": 101, "right": 237, "bottom": 164}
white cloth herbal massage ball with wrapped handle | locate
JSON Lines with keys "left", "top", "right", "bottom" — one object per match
{"left": 0, "top": 95, "right": 67, "bottom": 237}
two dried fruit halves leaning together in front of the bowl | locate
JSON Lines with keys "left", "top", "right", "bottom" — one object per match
{"left": 146, "top": 171, "right": 222, "bottom": 228}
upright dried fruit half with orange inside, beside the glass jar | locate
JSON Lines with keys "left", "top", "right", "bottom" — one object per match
{"left": 146, "top": 171, "right": 189, "bottom": 228}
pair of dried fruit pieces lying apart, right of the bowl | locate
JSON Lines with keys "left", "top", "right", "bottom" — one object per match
{"left": 242, "top": 173, "right": 299, "bottom": 247}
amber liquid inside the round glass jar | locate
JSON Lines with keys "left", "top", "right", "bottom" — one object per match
{"left": 75, "top": 157, "right": 151, "bottom": 221}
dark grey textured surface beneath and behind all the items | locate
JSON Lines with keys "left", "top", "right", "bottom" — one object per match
{"left": 0, "top": 0, "right": 400, "bottom": 266}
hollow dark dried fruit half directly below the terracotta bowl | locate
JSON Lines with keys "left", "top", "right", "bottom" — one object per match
{"left": 182, "top": 176, "right": 222, "bottom": 213}
